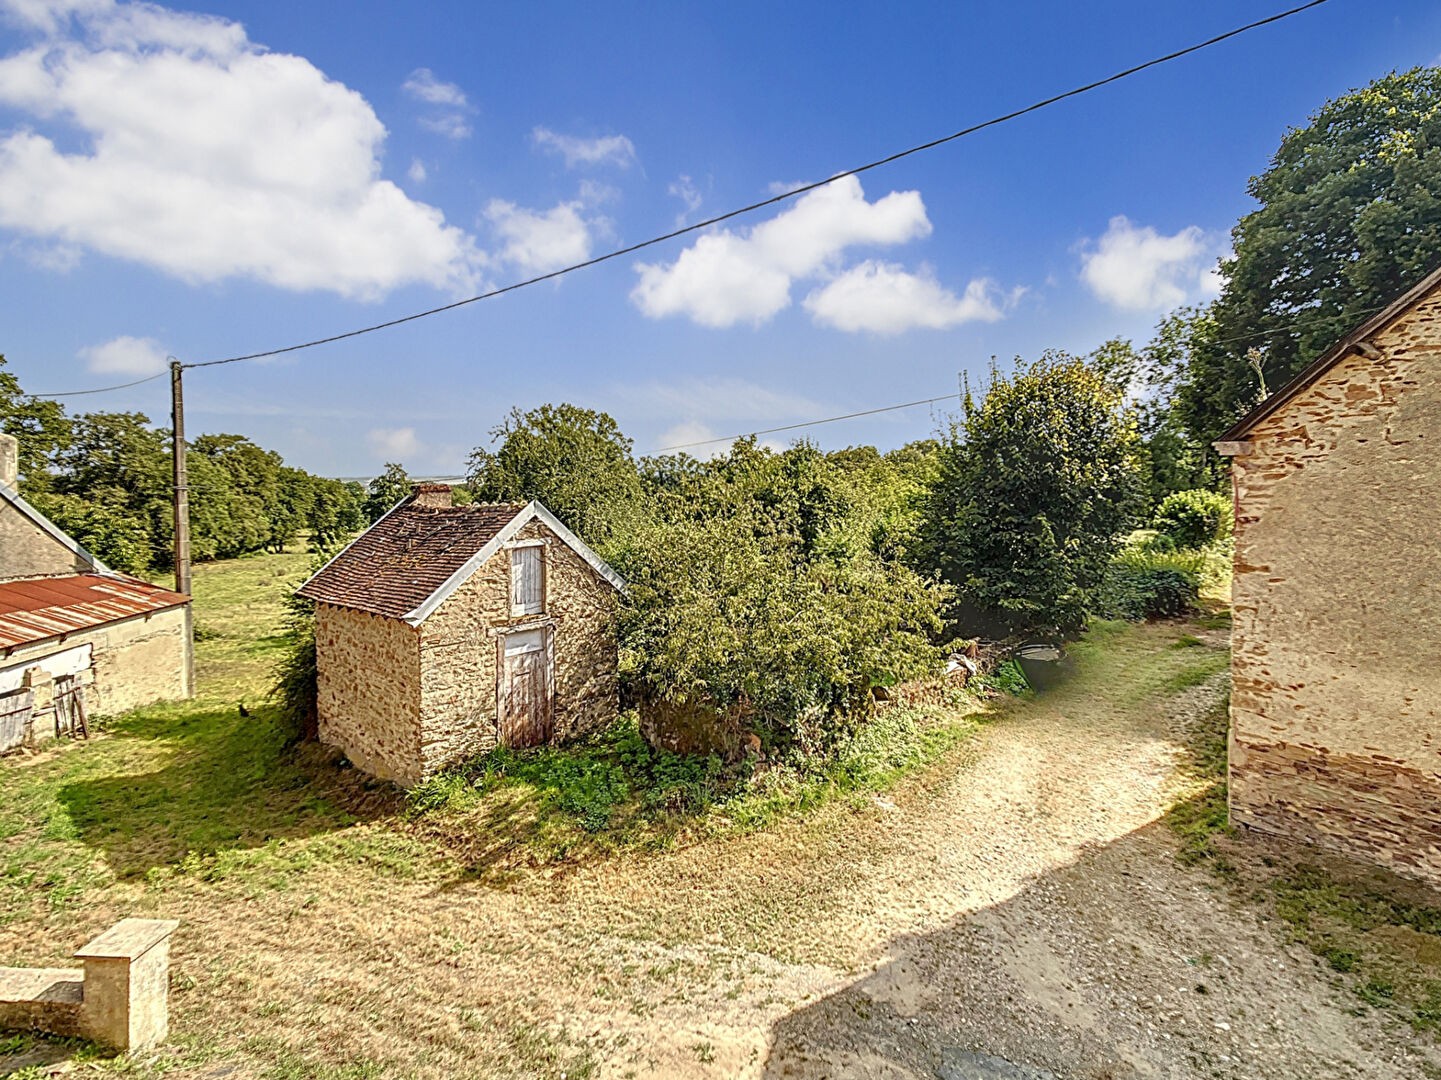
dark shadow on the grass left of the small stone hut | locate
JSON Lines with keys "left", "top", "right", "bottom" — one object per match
{"left": 56, "top": 702, "right": 401, "bottom": 877}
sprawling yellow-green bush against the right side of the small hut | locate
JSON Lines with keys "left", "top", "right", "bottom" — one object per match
{"left": 618, "top": 518, "right": 944, "bottom": 753}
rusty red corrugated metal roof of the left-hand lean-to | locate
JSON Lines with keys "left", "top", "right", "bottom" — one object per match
{"left": 0, "top": 574, "right": 190, "bottom": 649}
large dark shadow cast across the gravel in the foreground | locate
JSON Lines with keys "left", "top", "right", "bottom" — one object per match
{"left": 764, "top": 822, "right": 1441, "bottom": 1080}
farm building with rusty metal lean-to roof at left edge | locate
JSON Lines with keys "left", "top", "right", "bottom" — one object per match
{"left": 0, "top": 435, "right": 195, "bottom": 750}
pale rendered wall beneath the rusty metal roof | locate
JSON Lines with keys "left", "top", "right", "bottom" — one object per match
{"left": 0, "top": 606, "right": 193, "bottom": 738}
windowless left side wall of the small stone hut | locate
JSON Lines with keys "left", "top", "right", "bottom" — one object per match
{"left": 316, "top": 604, "right": 424, "bottom": 784}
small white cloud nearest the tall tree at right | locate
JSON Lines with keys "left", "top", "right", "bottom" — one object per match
{"left": 1081, "top": 215, "right": 1221, "bottom": 311}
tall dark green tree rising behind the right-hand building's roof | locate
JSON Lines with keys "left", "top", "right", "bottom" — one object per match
{"left": 1177, "top": 68, "right": 1441, "bottom": 453}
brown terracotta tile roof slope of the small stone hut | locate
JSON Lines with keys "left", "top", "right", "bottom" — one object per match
{"left": 295, "top": 499, "right": 526, "bottom": 619}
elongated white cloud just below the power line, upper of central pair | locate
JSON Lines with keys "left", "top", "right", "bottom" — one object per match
{"left": 631, "top": 176, "right": 931, "bottom": 327}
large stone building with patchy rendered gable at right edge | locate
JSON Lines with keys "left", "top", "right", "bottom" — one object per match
{"left": 1216, "top": 263, "right": 1441, "bottom": 884}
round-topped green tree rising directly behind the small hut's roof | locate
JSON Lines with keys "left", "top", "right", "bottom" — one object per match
{"left": 468, "top": 404, "right": 641, "bottom": 548}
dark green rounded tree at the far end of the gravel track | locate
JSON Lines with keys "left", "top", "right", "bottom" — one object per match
{"left": 921, "top": 353, "right": 1140, "bottom": 634}
